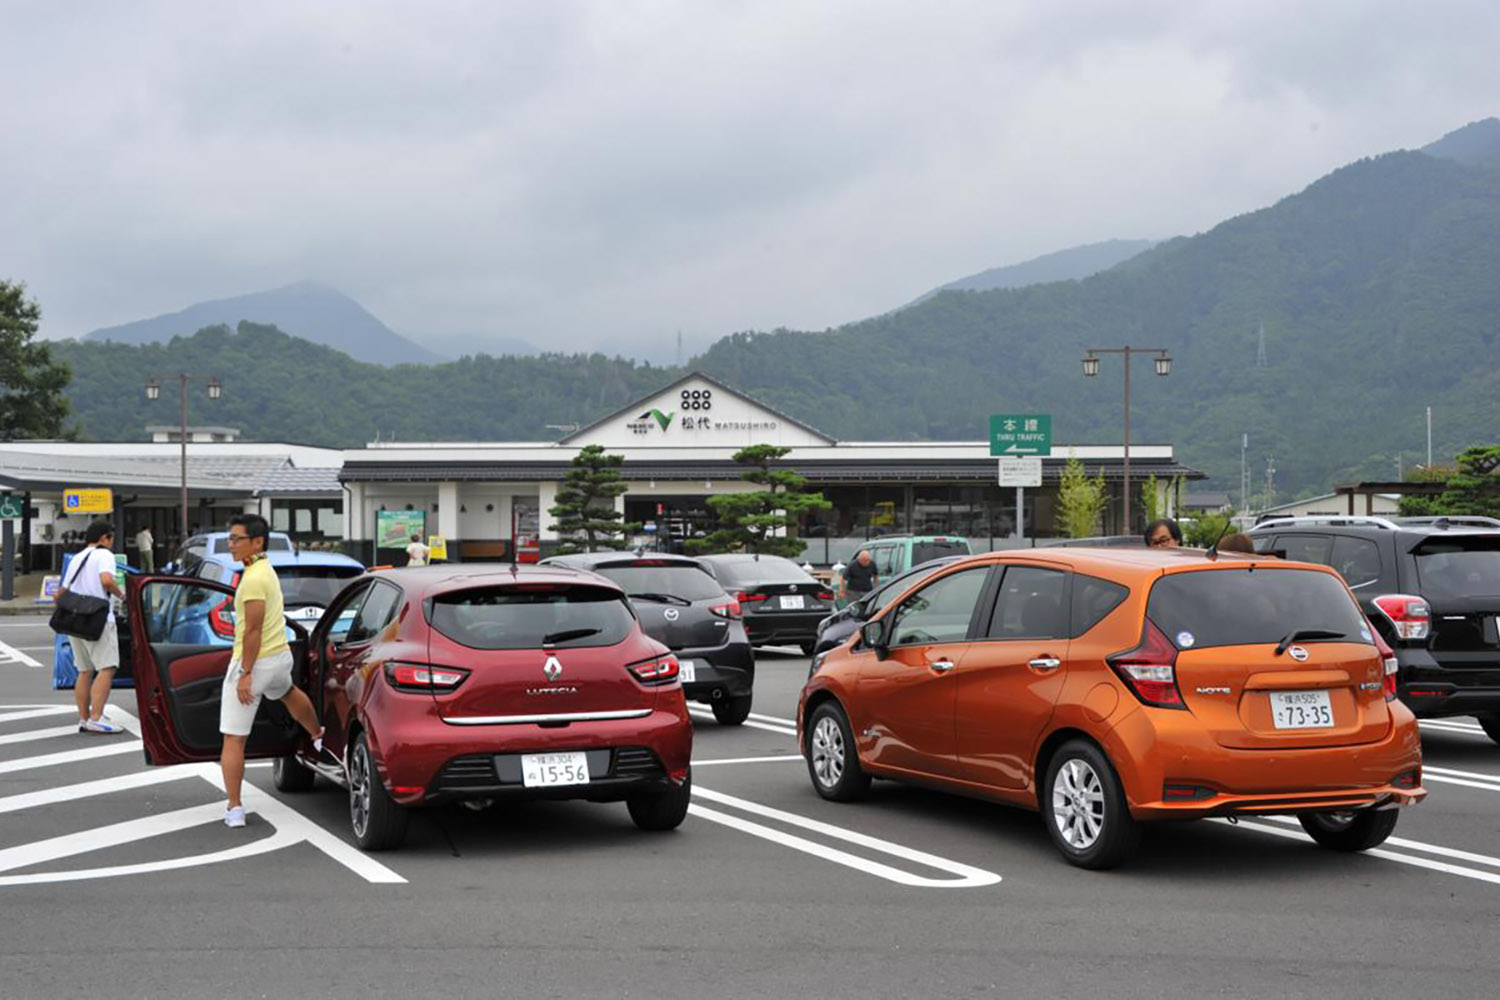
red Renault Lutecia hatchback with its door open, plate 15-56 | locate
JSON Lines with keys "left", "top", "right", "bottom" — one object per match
{"left": 129, "top": 565, "right": 693, "bottom": 850}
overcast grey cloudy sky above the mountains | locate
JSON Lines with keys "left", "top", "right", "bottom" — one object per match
{"left": 0, "top": 0, "right": 1500, "bottom": 354}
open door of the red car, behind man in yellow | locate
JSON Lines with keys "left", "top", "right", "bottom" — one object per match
{"left": 126, "top": 576, "right": 308, "bottom": 765}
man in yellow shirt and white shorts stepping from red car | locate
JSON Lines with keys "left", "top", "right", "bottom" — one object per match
{"left": 219, "top": 514, "right": 323, "bottom": 826}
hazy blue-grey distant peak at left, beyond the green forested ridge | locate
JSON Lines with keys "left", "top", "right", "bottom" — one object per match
{"left": 84, "top": 282, "right": 443, "bottom": 364}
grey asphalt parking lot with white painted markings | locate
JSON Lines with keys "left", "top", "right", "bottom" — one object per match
{"left": 0, "top": 618, "right": 1500, "bottom": 1000}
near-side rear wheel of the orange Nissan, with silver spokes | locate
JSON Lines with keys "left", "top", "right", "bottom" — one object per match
{"left": 1038, "top": 739, "right": 1140, "bottom": 870}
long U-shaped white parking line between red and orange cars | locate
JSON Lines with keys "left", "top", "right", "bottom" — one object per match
{"left": 689, "top": 786, "right": 1001, "bottom": 889}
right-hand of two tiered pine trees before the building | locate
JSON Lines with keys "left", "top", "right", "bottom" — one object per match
{"left": 689, "top": 444, "right": 833, "bottom": 556}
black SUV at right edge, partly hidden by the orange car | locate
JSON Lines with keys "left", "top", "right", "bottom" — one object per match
{"left": 1250, "top": 517, "right": 1500, "bottom": 744}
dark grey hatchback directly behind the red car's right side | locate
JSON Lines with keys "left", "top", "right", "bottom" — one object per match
{"left": 542, "top": 552, "right": 755, "bottom": 726}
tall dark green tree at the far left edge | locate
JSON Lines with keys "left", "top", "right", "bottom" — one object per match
{"left": 0, "top": 280, "right": 72, "bottom": 441}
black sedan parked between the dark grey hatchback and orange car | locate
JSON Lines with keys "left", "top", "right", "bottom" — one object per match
{"left": 698, "top": 555, "right": 834, "bottom": 655}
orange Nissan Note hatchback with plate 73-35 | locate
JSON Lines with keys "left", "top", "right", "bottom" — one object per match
{"left": 798, "top": 549, "right": 1427, "bottom": 868}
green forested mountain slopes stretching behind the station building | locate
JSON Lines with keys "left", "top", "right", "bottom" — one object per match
{"left": 46, "top": 120, "right": 1500, "bottom": 499}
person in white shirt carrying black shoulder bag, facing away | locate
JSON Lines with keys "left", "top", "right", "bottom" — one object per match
{"left": 53, "top": 520, "right": 125, "bottom": 733}
